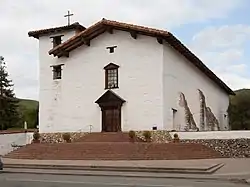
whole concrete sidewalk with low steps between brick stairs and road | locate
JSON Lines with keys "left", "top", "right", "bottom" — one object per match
{"left": 3, "top": 158, "right": 250, "bottom": 181}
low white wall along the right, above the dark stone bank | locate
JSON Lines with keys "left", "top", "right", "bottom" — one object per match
{"left": 170, "top": 131, "right": 250, "bottom": 140}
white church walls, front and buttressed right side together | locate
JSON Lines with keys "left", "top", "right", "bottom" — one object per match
{"left": 36, "top": 30, "right": 229, "bottom": 133}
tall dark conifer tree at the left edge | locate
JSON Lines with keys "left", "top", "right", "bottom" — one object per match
{"left": 0, "top": 56, "right": 19, "bottom": 130}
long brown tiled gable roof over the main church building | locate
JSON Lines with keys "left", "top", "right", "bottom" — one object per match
{"left": 49, "top": 19, "right": 235, "bottom": 95}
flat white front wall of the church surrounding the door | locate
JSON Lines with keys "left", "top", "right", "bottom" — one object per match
{"left": 39, "top": 31, "right": 163, "bottom": 132}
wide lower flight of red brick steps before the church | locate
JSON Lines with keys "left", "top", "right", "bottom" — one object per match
{"left": 4, "top": 142, "right": 222, "bottom": 160}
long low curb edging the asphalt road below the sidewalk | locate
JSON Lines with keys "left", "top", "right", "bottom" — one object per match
{"left": 0, "top": 170, "right": 250, "bottom": 184}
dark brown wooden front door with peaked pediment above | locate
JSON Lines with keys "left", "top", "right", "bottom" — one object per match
{"left": 95, "top": 90, "right": 125, "bottom": 132}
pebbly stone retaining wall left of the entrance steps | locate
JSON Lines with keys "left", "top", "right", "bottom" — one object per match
{"left": 40, "top": 132, "right": 88, "bottom": 143}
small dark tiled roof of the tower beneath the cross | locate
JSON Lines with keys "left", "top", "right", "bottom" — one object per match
{"left": 28, "top": 22, "right": 86, "bottom": 39}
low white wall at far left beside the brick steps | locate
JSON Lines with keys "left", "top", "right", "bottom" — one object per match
{"left": 0, "top": 133, "right": 33, "bottom": 155}
